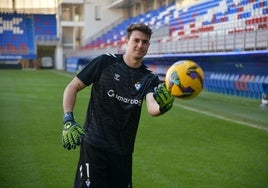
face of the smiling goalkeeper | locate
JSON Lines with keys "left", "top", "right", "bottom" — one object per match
{"left": 126, "top": 30, "right": 150, "bottom": 60}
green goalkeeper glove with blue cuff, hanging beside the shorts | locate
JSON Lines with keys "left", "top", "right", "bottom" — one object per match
{"left": 62, "top": 112, "right": 85, "bottom": 150}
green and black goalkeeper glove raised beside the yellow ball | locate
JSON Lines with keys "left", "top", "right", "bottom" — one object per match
{"left": 153, "top": 83, "right": 174, "bottom": 114}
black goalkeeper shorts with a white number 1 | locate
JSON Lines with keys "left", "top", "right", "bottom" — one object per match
{"left": 74, "top": 139, "right": 132, "bottom": 188}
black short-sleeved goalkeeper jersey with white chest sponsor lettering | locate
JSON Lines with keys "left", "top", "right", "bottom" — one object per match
{"left": 77, "top": 54, "right": 160, "bottom": 154}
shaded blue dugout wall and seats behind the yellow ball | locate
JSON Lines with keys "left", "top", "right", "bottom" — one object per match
{"left": 144, "top": 51, "right": 268, "bottom": 99}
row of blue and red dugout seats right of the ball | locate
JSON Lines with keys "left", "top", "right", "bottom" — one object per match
{"left": 204, "top": 72, "right": 268, "bottom": 99}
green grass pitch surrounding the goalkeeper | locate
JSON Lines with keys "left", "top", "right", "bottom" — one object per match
{"left": 0, "top": 70, "right": 268, "bottom": 188}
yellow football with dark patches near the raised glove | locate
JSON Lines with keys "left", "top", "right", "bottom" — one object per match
{"left": 165, "top": 60, "right": 204, "bottom": 99}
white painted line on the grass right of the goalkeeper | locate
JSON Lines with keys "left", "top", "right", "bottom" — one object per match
{"left": 174, "top": 103, "right": 268, "bottom": 131}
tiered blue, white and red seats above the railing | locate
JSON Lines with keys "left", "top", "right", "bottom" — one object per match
{"left": 84, "top": 0, "right": 268, "bottom": 49}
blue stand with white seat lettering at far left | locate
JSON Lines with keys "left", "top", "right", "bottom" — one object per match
{"left": 0, "top": 13, "right": 58, "bottom": 60}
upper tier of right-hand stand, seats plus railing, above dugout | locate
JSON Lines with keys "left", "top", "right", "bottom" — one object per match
{"left": 82, "top": 0, "right": 268, "bottom": 54}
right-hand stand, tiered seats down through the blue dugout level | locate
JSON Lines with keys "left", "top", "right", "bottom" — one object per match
{"left": 74, "top": 0, "right": 268, "bottom": 99}
